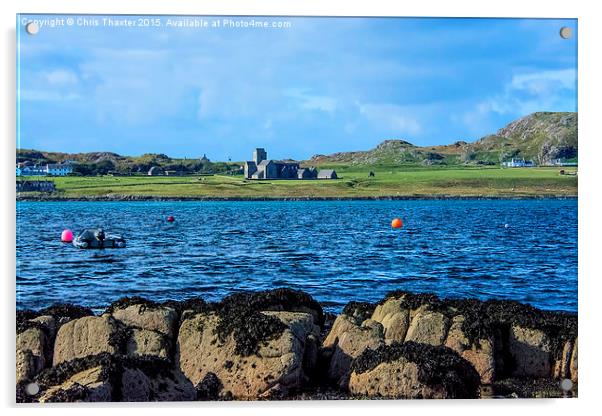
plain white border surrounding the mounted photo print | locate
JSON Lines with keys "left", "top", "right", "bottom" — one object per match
{"left": 0, "top": 0, "right": 602, "bottom": 415}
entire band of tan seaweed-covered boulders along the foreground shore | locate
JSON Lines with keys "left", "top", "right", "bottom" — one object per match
{"left": 16, "top": 289, "right": 578, "bottom": 402}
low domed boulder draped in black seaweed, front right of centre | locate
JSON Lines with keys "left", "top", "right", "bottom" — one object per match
{"left": 349, "top": 341, "right": 480, "bottom": 399}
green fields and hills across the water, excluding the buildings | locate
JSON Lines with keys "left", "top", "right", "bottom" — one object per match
{"left": 17, "top": 113, "right": 578, "bottom": 198}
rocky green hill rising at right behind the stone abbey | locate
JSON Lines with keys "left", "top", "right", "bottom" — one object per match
{"left": 306, "top": 112, "right": 578, "bottom": 166}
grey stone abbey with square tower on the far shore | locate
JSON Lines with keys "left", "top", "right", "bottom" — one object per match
{"left": 243, "top": 148, "right": 328, "bottom": 179}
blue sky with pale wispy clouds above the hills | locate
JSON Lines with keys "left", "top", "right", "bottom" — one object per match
{"left": 17, "top": 16, "right": 577, "bottom": 160}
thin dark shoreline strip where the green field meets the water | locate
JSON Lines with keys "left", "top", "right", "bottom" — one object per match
{"left": 16, "top": 194, "right": 578, "bottom": 202}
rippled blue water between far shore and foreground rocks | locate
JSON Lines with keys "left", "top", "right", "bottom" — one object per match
{"left": 17, "top": 200, "right": 577, "bottom": 311}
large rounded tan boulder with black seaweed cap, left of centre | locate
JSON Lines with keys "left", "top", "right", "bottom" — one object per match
{"left": 176, "top": 295, "right": 322, "bottom": 399}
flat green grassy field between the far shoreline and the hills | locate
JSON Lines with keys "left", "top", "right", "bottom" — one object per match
{"left": 20, "top": 166, "right": 577, "bottom": 198}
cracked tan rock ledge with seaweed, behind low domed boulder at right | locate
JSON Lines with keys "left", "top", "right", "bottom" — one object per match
{"left": 324, "top": 292, "right": 577, "bottom": 385}
